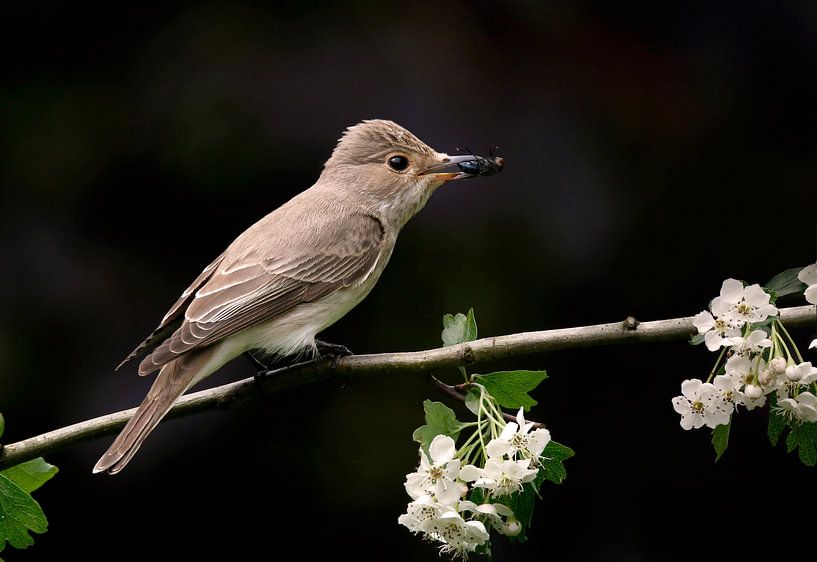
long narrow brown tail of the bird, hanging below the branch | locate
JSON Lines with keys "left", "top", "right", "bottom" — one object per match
{"left": 94, "top": 347, "right": 213, "bottom": 474}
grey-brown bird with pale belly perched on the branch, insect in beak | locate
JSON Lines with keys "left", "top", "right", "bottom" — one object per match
{"left": 93, "top": 119, "right": 504, "bottom": 474}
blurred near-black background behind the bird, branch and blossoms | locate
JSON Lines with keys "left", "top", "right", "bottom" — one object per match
{"left": 0, "top": 1, "right": 817, "bottom": 561}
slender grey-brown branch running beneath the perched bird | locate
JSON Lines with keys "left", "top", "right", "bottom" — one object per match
{"left": 0, "top": 306, "right": 817, "bottom": 469}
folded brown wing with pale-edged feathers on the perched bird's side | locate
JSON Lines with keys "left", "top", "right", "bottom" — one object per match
{"left": 139, "top": 214, "right": 385, "bottom": 375}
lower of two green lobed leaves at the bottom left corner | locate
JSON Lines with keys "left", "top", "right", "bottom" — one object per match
{"left": 0, "top": 474, "right": 48, "bottom": 551}
